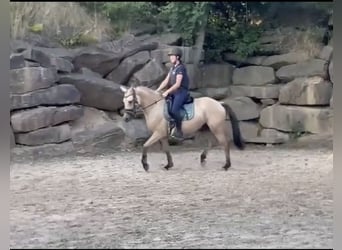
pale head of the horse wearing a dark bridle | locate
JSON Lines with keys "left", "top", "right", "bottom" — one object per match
{"left": 120, "top": 86, "right": 140, "bottom": 122}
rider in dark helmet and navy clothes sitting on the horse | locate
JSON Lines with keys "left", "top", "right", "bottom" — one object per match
{"left": 157, "top": 48, "right": 189, "bottom": 139}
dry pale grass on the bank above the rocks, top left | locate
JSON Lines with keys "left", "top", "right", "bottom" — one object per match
{"left": 10, "top": 2, "right": 112, "bottom": 46}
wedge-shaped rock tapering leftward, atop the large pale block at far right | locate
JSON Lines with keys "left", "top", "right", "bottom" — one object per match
{"left": 276, "top": 59, "right": 328, "bottom": 82}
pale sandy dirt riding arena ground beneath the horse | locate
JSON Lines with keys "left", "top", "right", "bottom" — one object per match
{"left": 10, "top": 140, "right": 333, "bottom": 248}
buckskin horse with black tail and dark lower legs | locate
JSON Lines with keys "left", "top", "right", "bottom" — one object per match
{"left": 120, "top": 86, "right": 245, "bottom": 171}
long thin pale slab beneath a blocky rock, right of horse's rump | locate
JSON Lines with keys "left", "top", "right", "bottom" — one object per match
{"left": 230, "top": 84, "right": 283, "bottom": 99}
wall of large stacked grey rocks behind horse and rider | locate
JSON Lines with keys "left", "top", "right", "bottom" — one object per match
{"left": 10, "top": 31, "right": 334, "bottom": 158}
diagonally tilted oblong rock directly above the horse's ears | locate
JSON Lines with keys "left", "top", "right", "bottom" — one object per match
{"left": 106, "top": 51, "right": 150, "bottom": 84}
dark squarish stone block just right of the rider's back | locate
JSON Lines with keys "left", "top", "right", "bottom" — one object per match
{"left": 200, "top": 63, "right": 234, "bottom": 88}
